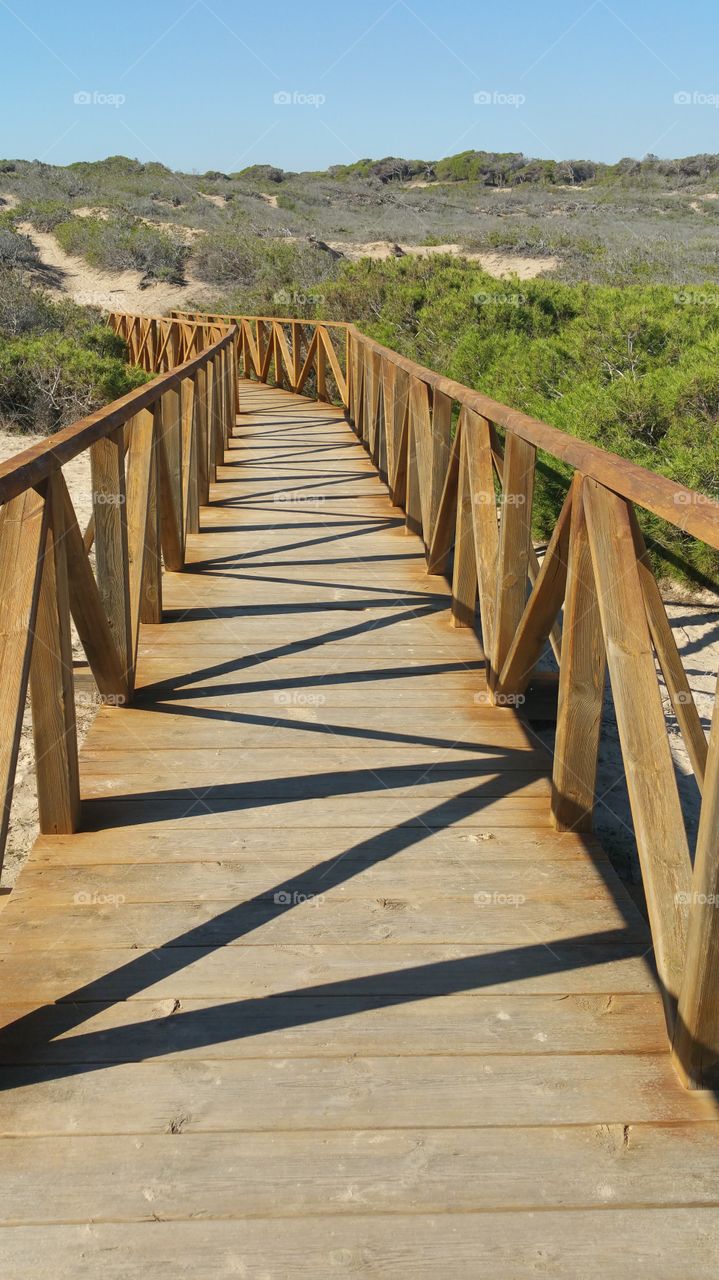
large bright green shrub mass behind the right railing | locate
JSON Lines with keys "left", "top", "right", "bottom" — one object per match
{"left": 325, "top": 257, "right": 719, "bottom": 580}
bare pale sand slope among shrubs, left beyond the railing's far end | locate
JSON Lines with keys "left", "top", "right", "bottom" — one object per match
{"left": 19, "top": 223, "right": 212, "bottom": 315}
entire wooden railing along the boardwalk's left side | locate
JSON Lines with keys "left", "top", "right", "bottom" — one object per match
{"left": 0, "top": 315, "right": 237, "bottom": 867}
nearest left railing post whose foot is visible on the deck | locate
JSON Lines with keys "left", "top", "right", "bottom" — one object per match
{"left": 29, "top": 472, "right": 79, "bottom": 836}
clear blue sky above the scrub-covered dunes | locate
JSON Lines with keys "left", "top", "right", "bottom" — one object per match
{"left": 0, "top": 0, "right": 719, "bottom": 172}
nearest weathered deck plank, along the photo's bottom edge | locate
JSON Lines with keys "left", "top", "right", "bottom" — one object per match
{"left": 4, "top": 1207, "right": 719, "bottom": 1280}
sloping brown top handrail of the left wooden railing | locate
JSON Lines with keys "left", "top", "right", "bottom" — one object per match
{"left": 0, "top": 316, "right": 234, "bottom": 504}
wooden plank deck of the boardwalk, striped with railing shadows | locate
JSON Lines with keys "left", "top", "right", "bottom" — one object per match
{"left": 0, "top": 384, "right": 719, "bottom": 1280}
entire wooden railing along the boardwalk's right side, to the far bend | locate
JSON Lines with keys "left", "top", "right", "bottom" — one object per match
{"left": 183, "top": 314, "right": 719, "bottom": 1087}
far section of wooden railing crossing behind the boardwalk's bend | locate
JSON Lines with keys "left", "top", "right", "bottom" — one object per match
{"left": 173, "top": 311, "right": 352, "bottom": 407}
